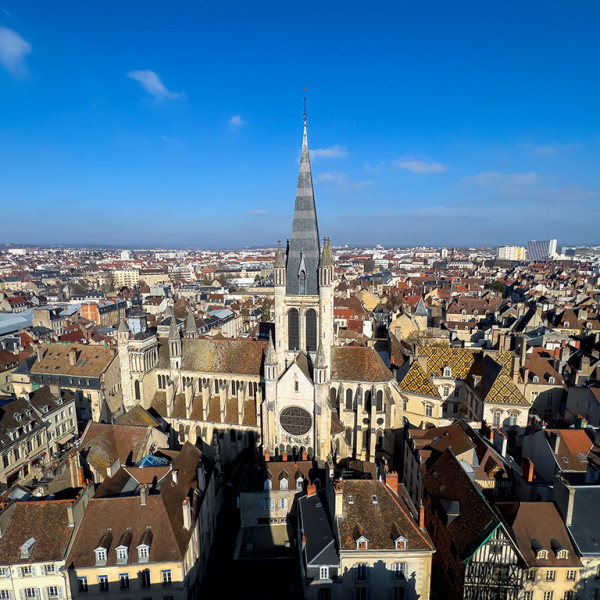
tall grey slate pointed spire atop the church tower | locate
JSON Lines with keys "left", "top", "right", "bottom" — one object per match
{"left": 286, "top": 98, "right": 321, "bottom": 296}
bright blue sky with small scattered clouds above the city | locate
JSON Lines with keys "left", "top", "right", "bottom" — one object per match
{"left": 0, "top": 0, "right": 600, "bottom": 248}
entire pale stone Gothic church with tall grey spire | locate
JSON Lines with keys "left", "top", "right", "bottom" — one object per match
{"left": 118, "top": 115, "right": 402, "bottom": 462}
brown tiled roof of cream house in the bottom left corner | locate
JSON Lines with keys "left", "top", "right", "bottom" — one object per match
{"left": 0, "top": 500, "right": 73, "bottom": 565}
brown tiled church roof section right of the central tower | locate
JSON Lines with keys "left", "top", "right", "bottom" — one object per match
{"left": 331, "top": 346, "right": 394, "bottom": 382}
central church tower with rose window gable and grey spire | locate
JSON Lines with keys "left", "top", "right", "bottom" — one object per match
{"left": 262, "top": 107, "right": 333, "bottom": 459}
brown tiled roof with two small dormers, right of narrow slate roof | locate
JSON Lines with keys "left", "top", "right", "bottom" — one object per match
{"left": 338, "top": 479, "right": 433, "bottom": 552}
